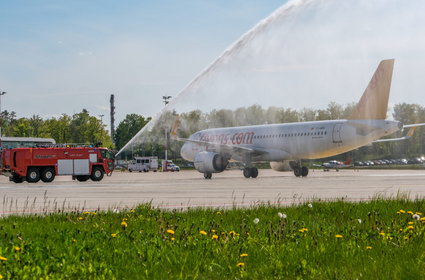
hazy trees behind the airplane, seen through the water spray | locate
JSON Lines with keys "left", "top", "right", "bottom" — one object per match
{"left": 116, "top": 102, "right": 425, "bottom": 162}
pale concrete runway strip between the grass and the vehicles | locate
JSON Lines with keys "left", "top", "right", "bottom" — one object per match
{"left": 0, "top": 169, "right": 425, "bottom": 215}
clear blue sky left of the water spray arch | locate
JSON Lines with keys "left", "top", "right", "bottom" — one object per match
{"left": 0, "top": 0, "right": 285, "bottom": 125}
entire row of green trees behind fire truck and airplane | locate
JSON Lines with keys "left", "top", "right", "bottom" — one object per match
{"left": 0, "top": 102, "right": 425, "bottom": 159}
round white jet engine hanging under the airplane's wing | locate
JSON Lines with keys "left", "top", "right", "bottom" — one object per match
{"left": 194, "top": 152, "right": 229, "bottom": 173}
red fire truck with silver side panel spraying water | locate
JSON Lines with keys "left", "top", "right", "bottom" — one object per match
{"left": 1, "top": 146, "right": 114, "bottom": 183}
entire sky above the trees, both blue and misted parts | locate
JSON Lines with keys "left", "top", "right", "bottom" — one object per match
{"left": 0, "top": 0, "right": 425, "bottom": 147}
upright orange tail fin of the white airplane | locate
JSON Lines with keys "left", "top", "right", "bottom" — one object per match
{"left": 348, "top": 59, "right": 394, "bottom": 120}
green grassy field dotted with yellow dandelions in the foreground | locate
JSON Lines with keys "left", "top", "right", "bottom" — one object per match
{"left": 0, "top": 199, "right": 425, "bottom": 279}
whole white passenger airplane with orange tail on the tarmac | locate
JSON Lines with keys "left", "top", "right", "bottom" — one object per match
{"left": 170, "top": 59, "right": 425, "bottom": 179}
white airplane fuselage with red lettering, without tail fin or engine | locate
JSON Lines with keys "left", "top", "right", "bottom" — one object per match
{"left": 181, "top": 120, "right": 402, "bottom": 161}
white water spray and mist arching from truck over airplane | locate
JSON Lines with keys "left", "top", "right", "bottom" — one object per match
{"left": 119, "top": 0, "right": 425, "bottom": 159}
